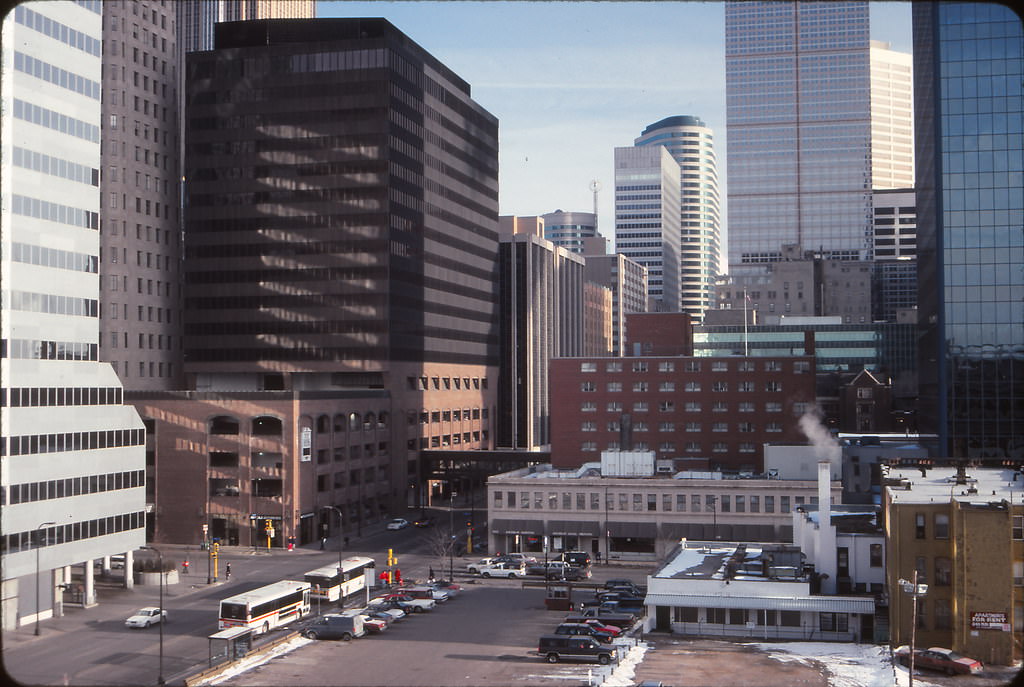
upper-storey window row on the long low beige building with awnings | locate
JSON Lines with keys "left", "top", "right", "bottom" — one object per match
{"left": 493, "top": 489, "right": 818, "bottom": 513}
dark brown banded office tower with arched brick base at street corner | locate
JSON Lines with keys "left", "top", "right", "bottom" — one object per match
{"left": 133, "top": 19, "right": 499, "bottom": 544}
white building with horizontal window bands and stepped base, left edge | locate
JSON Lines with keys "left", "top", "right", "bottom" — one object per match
{"left": 0, "top": 2, "right": 145, "bottom": 630}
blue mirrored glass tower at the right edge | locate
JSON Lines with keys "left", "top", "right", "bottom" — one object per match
{"left": 913, "top": 3, "right": 1024, "bottom": 461}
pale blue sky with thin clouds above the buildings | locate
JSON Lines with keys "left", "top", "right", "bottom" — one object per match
{"left": 317, "top": 0, "right": 911, "bottom": 247}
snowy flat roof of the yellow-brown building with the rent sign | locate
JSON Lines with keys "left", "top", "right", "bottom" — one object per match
{"left": 883, "top": 467, "right": 1024, "bottom": 505}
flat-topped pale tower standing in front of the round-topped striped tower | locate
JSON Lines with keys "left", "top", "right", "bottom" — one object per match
{"left": 615, "top": 145, "right": 680, "bottom": 312}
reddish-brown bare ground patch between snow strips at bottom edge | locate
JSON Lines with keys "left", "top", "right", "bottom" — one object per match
{"left": 634, "top": 634, "right": 828, "bottom": 687}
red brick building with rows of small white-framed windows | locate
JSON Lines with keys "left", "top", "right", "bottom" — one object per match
{"left": 549, "top": 313, "right": 815, "bottom": 472}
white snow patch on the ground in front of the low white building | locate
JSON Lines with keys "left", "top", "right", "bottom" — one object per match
{"left": 749, "top": 642, "right": 936, "bottom": 687}
